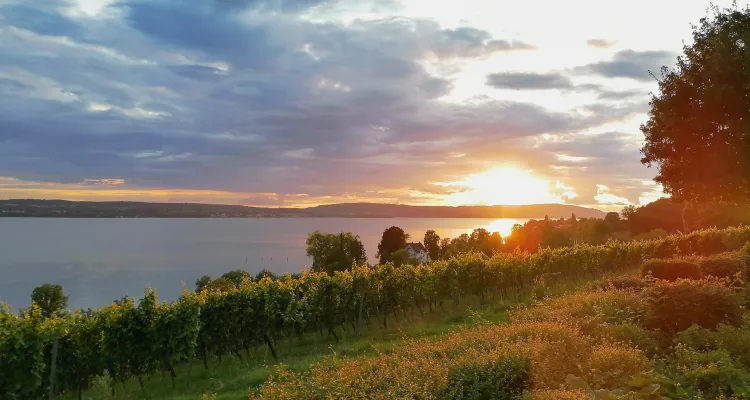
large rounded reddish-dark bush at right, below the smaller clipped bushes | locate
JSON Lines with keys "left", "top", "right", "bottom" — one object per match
{"left": 644, "top": 280, "right": 742, "bottom": 335}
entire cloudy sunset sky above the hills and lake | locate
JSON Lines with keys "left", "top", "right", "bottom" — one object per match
{"left": 0, "top": 0, "right": 742, "bottom": 210}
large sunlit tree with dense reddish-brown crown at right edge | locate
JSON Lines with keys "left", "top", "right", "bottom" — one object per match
{"left": 641, "top": 7, "right": 750, "bottom": 203}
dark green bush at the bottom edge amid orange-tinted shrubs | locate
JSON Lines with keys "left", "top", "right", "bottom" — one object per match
{"left": 440, "top": 354, "right": 531, "bottom": 400}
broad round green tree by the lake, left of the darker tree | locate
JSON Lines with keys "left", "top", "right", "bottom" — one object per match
{"left": 307, "top": 231, "right": 367, "bottom": 275}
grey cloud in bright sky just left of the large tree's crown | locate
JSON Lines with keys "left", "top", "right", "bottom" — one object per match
{"left": 576, "top": 50, "right": 677, "bottom": 82}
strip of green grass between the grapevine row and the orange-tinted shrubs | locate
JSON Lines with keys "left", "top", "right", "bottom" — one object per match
{"left": 72, "top": 272, "right": 636, "bottom": 400}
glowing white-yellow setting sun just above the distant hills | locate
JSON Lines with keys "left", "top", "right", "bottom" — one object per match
{"left": 438, "top": 167, "right": 574, "bottom": 206}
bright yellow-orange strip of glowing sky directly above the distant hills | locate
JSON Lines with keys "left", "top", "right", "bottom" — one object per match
{"left": 0, "top": 165, "right": 660, "bottom": 212}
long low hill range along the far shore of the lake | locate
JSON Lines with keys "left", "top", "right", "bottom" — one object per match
{"left": 0, "top": 199, "right": 605, "bottom": 218}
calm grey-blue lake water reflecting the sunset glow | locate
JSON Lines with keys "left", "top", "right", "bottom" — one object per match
{"left": 0, "top": 218, "right": 527, "bottom": 310}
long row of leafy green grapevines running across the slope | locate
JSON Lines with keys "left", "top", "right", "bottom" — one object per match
{"left": 0, "top": 228, "right": 750, "bottom": 399}
